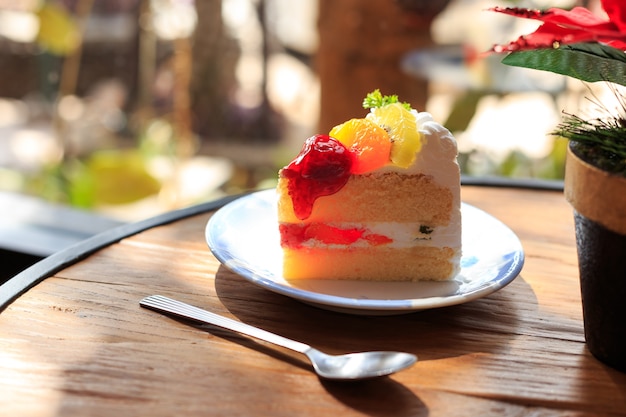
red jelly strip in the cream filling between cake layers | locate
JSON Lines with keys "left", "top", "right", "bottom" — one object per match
{"left": 279, "top": 223, "right": 392, "bottom": 248}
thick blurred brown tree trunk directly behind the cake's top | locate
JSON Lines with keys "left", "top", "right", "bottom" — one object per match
{"left": 316, "top": 0, "right": 448, "bottom": 132}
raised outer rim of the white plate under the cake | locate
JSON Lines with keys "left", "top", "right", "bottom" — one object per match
{"left": 205, "top": 188, "right": 525, "bottom": 314}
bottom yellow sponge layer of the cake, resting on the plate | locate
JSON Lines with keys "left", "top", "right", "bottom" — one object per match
{"left": 283, "top": 247, "right": 458, "bottom": 281}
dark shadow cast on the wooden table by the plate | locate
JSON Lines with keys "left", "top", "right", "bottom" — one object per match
{"left": 215, "top": 266, "right": 537, "bottom": 361}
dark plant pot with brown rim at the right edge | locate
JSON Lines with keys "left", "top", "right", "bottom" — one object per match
{"left": 565, "top": 142, "right": 626, "bottom": 372}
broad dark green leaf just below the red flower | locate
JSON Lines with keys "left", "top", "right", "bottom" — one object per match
{"left": 502, "top": 43, "right": 626, "bottom": 86}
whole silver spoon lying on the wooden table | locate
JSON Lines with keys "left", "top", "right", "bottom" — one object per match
{"left": 139, "top": 295, "right": 417, "bottom": 380}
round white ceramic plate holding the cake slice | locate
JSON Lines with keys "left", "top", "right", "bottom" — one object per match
{"left": 205, "top": 190, "right": 524, "bottom": 315}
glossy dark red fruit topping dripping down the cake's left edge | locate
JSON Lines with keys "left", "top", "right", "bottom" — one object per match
{"left": 281, "top": 135, "right": 356, "bottom": 220}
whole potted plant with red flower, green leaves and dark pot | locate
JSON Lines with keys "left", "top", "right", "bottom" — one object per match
{"left": 491, "top": 0, "right": 626, "bottom": 372}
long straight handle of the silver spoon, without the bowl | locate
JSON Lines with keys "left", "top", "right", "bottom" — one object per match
{"left": 139, "top": 295, "right": 311, "bottom": 353}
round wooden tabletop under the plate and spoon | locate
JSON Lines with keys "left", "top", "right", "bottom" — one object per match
{"left": 0, "top": 186, "right": 626, "bottom": 417}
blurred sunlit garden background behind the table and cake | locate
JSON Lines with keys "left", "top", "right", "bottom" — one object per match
{"left": 0, "top": 0, "right": 601, "bottom": 264}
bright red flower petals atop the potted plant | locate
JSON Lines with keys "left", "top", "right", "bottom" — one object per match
{"left": 490, "top": 0, "right": 626, "bottom": 53}
